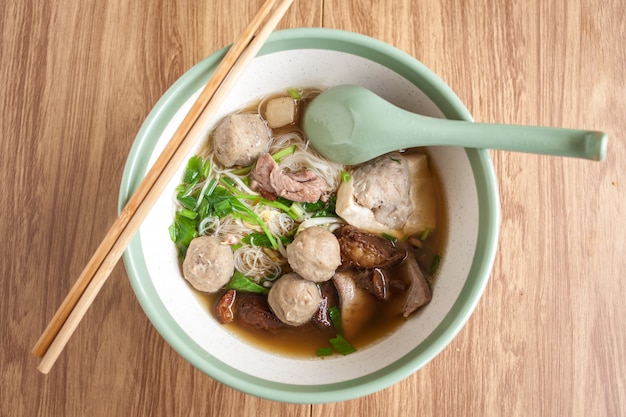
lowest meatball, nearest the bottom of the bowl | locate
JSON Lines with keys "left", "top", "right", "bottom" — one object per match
{"left": 267, "top": 272, "right": 322, "bottom": 326}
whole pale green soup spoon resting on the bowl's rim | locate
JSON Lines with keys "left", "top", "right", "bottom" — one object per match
{"left": 303, "top": 85, "right": 608, "bottom": 165}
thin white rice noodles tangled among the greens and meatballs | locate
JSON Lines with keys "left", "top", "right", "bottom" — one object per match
{"left": 177, "top": 89, "right": 344, "bottom": 285}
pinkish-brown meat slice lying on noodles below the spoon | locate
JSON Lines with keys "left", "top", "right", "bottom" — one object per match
{"left": 251, "top": 153, "right": 332, "bottom": 203}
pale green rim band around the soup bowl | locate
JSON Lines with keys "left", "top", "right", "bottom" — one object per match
{"left": 119, "top": 28, "right": 500, "bottom": 403}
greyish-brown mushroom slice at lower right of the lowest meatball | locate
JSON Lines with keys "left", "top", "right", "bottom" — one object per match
{"left": 333, "top": 270, "right": 376, "bottom": 339}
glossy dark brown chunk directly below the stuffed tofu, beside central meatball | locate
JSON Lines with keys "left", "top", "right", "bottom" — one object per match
{"left": 337, "top": 225, "right": 406, "bottom": 269}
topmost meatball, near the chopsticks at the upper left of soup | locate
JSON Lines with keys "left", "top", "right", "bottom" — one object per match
{"left": 213, "top": 114, "right": 270, "bottom": 167}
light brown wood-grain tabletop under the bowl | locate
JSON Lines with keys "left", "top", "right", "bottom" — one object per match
{"left": 0, "top": 0, "right": 626, "bottom": 417}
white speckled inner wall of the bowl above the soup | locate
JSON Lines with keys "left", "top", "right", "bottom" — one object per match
{"left": 139, "top": 49, "right": 479, "bottom": 385}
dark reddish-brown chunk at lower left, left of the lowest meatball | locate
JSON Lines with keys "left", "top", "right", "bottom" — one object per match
{"left": 215, "top": 290, "right": 284, "bottom": 334}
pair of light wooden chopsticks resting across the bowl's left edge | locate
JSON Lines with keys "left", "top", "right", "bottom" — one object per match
{"left": 32, "top": 0, "right": 293, "bottom": 374}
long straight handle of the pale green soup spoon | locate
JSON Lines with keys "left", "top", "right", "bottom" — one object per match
{"left": 408, "top": 117, "right": 608, "bottom": 161}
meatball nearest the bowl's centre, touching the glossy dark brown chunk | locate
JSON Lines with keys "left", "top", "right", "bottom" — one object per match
{"left": 287, "top": 227, "right": 341, "bottom": 282}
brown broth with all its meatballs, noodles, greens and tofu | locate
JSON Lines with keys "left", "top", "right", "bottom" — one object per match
{"left": 169, "top": 88, "right": 446, "bottom": 357}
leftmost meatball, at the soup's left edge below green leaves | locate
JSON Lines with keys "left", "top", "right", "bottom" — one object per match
{"left": 183, "top": 236, "right": 235, "bottom": 293}
